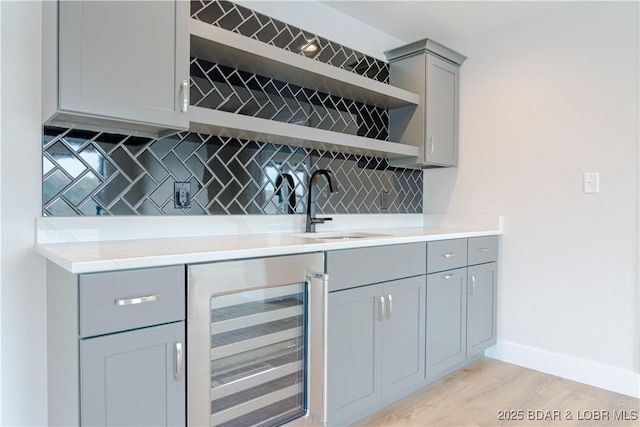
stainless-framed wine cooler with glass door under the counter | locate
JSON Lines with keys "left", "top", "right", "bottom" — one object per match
{"left": 187, "top": 254, "right": 322, "bottom": 427}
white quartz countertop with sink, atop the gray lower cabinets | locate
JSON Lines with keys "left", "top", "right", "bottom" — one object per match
{"left": 36, "top": 226, "right": 501, "bottom": 273}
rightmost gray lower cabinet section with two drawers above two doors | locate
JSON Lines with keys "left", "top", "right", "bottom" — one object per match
{"left": 426, "top": 236, "right": 498, "bottom": 381}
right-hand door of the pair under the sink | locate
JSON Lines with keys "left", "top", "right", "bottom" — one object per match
{"left": 382, "top": 276, "right": 426, "bottom": 398}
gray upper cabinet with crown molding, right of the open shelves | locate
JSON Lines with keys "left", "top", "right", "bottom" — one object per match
{"left": 385, "top": 39, "right": 466, "bottom": 168}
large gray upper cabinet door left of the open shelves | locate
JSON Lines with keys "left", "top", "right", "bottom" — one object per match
{"left": 58, "top": 0, "right": 189, "bottom": 129}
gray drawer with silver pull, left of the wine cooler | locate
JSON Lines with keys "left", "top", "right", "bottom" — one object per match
{"left": 80, "top": 266, "right": 185, "bottom": 337}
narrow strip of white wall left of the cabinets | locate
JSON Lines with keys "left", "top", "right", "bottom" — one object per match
{"left": 0, "top": 0, "right": 47, "bottom": 426}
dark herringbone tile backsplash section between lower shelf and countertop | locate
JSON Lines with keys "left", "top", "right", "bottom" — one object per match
{"left": 43, "top": 127, "right": 422, "bottom": 216}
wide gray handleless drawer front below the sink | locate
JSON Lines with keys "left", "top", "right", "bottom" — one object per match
{"left": 326, "top": 243, "right": 427, "bottom": 291}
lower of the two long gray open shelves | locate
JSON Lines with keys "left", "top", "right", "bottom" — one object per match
{"left": 189, "top": 106, "right": 418, "bottom": 159}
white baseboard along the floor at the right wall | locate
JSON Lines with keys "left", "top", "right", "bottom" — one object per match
{"left": 485, "top": 341, "right": 640, "bottom": 398}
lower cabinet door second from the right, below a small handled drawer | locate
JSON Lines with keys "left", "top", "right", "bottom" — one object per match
{"left": 426, "top": 268, "right": 467, "bottom": 378}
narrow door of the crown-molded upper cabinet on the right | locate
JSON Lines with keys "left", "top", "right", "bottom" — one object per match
{"left": 424, "top": 55, "right": 460, "bottom": 166}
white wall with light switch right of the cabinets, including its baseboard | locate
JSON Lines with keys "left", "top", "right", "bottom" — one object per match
{"left": 425, "top": 2, "right": 640, "bottom": 397}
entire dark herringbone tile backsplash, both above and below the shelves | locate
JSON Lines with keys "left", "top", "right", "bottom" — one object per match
{"left": 42, "top": 1, "right": 422, "bottom": 216}
